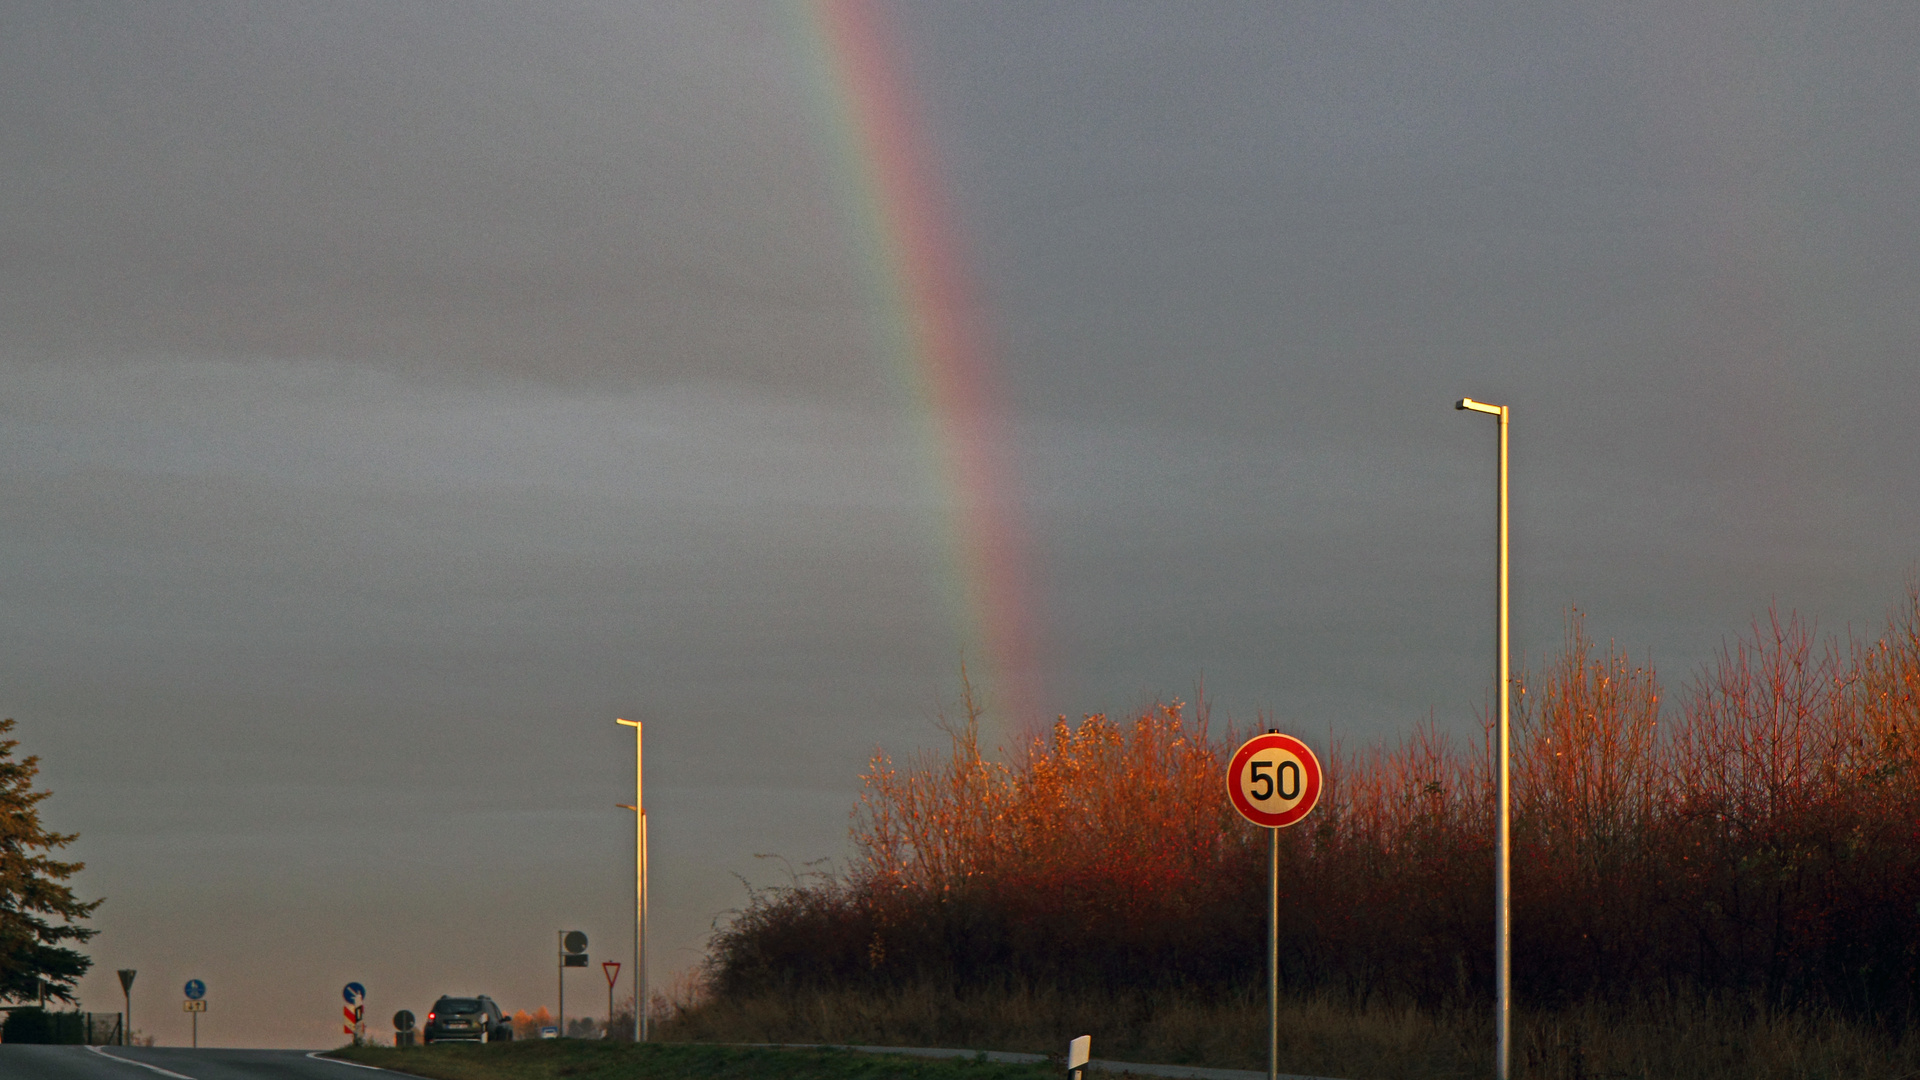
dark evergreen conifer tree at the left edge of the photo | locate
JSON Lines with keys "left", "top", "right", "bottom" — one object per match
{"left": 0, "top": 721, "right": 102, "bottom": 1003}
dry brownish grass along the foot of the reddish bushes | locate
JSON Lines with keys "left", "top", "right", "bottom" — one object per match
{"left": 659, "top": 986, "right": 1920, "bottom": 1080}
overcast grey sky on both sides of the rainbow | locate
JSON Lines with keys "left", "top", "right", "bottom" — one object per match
{"left": 0, "top": 2, "right": 1920, "bottom": 1045}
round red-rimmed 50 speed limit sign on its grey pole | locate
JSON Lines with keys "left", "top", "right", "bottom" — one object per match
{"left": 1227, "top": 730, "right": 1321, "bottom": 1080}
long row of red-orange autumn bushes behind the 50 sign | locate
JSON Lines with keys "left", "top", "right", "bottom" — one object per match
{"left": 710, "top": 588, "right": 1920, "bottom": 1017}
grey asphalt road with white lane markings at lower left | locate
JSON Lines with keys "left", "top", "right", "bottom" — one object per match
{"left": 0, "top": 1045, "right": 385, "bottom": 1080}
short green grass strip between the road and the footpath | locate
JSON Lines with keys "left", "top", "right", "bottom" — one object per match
{"left": 332, "top": 1040, "right": 1062, "bottom": 1080}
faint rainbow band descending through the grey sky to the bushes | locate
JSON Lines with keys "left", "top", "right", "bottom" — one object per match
{"left": 797, "top": 0, "right": 1041, "bottom": 742}
